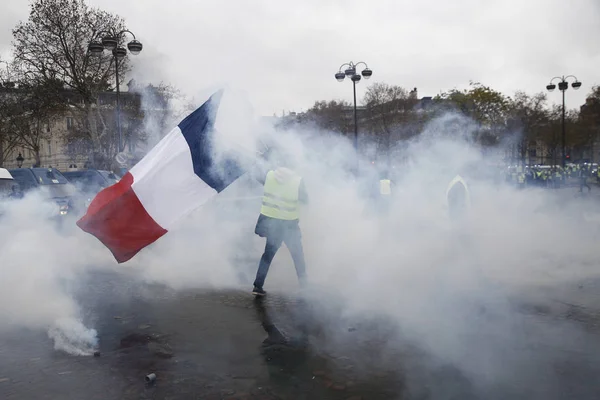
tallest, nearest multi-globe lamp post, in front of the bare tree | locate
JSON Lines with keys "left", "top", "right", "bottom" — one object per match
{"left": 88, "top": 29, "right": 143, "bottom": 153}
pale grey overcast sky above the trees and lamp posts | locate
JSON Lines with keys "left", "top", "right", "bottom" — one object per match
{"left": 0, "top": 0, "right": 600, "bottom": 115}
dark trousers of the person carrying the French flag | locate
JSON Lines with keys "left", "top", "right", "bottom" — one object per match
{"left": 254, "top": 228, "right": 306, "bottom": 288}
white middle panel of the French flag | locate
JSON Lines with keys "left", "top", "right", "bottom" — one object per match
{"left": 130, "top": 127, "right": 217, "bottom": 230}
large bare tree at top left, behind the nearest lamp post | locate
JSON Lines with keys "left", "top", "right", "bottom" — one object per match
{"left": 13, "top": 0, "right": 128, "bottom": 168}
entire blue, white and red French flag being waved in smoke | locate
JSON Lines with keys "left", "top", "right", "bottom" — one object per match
{"left": 77, "top": 91, "right": 245, "bottom": 263}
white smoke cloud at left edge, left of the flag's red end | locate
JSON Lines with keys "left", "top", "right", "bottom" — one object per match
{"left": 0, "top": 192, "right": 111, "bottom": 355}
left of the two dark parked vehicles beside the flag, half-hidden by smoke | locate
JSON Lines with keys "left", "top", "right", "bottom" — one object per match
{"left": 9, "top": 168, "right": 76, "bottom": 218}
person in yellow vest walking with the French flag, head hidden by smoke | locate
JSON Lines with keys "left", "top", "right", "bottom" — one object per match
{"left": 252, "top": 155, "right": 308, "bottom": 296}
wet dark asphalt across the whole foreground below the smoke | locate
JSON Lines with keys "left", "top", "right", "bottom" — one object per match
{"left": 0, "top": 271, "right": 600, "bottom": 400}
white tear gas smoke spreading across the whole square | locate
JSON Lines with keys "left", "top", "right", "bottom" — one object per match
{"left": 0, "top": 89, "right": 600, "bottom": 398}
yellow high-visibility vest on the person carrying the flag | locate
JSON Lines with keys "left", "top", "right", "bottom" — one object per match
{"left": 260, "top": 171, "right": 302, "bottom": 221}
